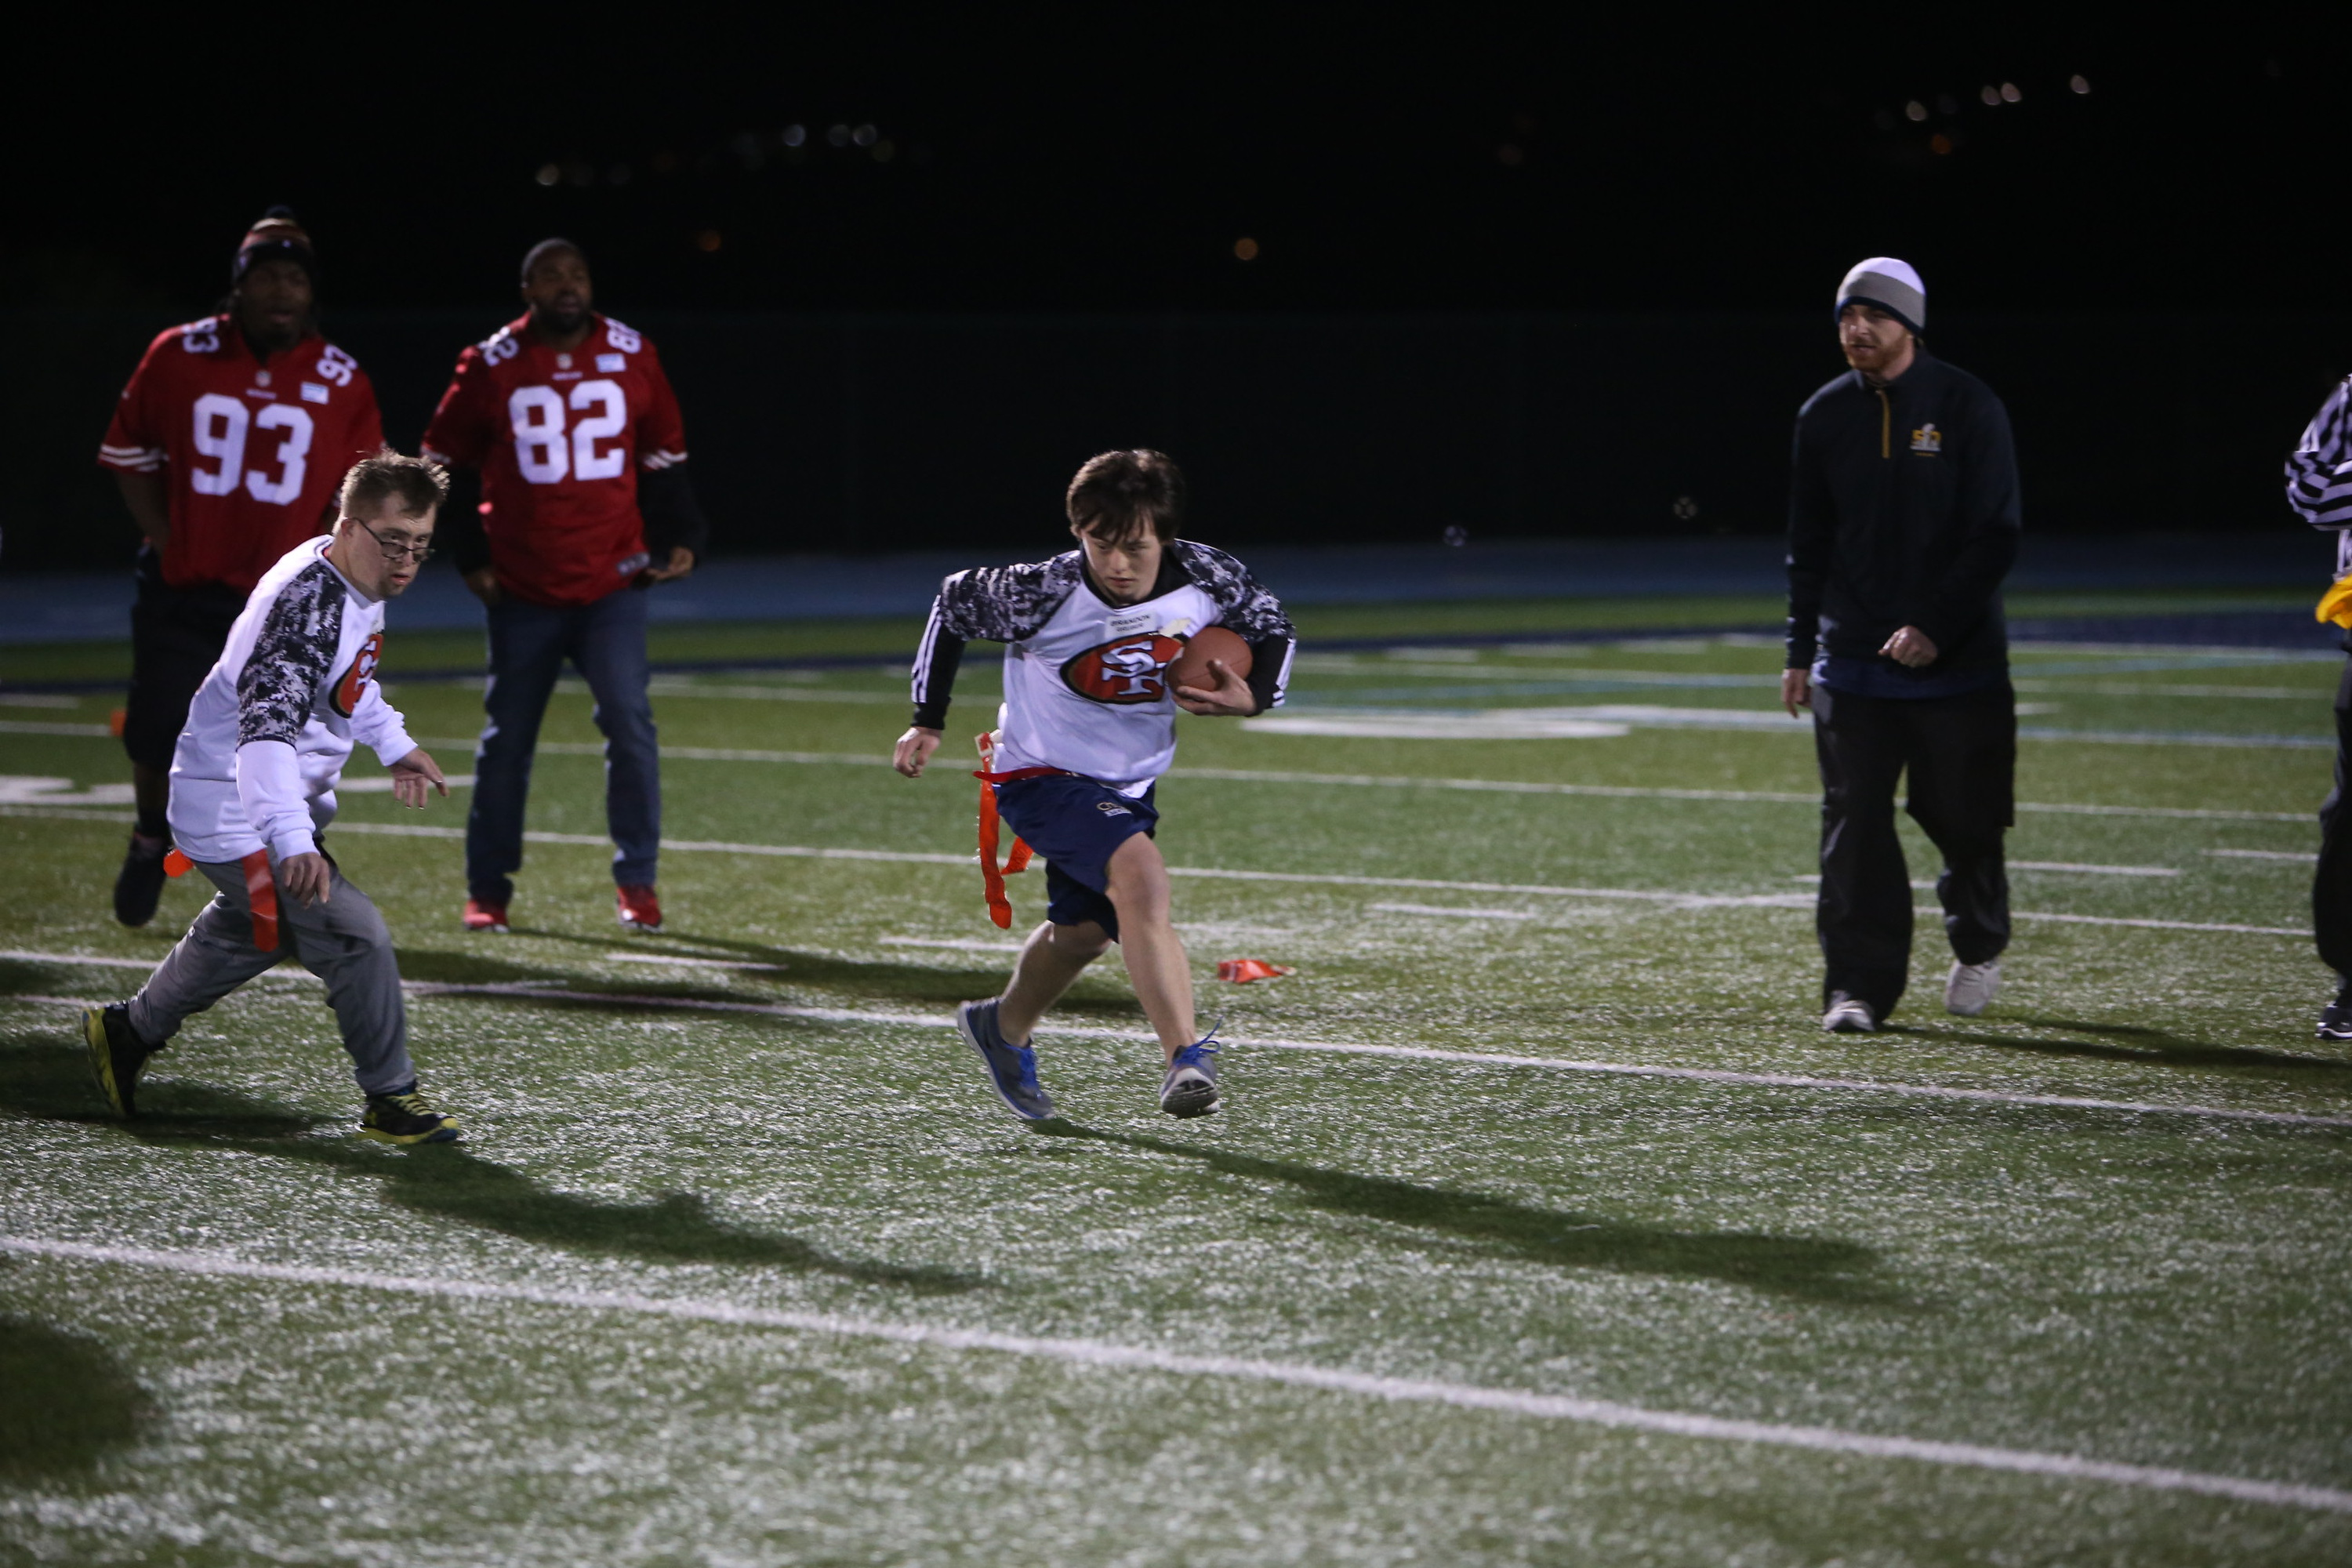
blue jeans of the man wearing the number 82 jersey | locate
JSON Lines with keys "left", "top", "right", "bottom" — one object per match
{"left": 466, "top": 588, "right": 661, "bottom": 905}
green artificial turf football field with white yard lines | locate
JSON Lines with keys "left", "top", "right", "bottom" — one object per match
{"left": 0, "top": 607, "right": 2352, "bottom": 1566}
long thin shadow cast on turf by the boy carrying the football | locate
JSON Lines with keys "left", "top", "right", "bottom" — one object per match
{"left": 1035, "top": 1119, "right": 1903, "bottom": 1307}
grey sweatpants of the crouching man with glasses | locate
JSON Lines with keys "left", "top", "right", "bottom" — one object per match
{"left": 132, "top": 860, "right": 416, "bottom": 1095}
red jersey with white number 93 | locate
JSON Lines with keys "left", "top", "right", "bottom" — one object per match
{"left": 99, "top": 315, "right": 383, "bottom": 593}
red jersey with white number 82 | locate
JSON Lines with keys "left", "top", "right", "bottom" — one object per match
{"left": 426, "top": 315, "right": 687, "bottom": 604}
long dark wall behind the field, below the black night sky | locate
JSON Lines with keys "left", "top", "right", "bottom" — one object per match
{"left": 0, "top": 301, "right": 2352, "bottom": 572}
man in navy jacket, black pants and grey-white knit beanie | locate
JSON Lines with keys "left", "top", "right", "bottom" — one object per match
{"left": 1780, "top": 256, "right": 2018, "bottom": 1032}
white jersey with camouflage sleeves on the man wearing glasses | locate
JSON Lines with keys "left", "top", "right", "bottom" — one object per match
{"left": 172, "top": 539, "right": 416, "bottom": 862}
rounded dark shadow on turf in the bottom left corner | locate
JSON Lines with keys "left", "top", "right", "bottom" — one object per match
{"left": 0, "top": 1314, "right": 155, "bottom": 1481}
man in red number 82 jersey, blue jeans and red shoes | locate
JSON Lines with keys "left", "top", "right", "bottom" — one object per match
{"left": 426, "top": 240, "right": 710, "bottom": 931}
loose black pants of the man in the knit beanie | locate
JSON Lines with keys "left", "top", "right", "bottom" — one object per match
{"left": 1813, "top": 680, "right": 2018, "bottom": 1018}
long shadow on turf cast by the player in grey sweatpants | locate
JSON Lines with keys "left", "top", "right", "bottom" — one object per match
{"left": 0, "top": 1046, "right": 988, "bottom": 1298}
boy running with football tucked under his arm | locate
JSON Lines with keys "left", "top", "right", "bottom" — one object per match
{"left": 891, "top": 452, "right": 1296, "bottom": 1121}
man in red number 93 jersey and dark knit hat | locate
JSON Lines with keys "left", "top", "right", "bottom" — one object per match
{"left": 99, "top": 207, "right": 383, "bottom": 926}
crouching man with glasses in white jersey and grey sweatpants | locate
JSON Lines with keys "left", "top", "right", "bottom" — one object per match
{"left": 82, "top": 449, "right": 456, "bottom": 1142}
